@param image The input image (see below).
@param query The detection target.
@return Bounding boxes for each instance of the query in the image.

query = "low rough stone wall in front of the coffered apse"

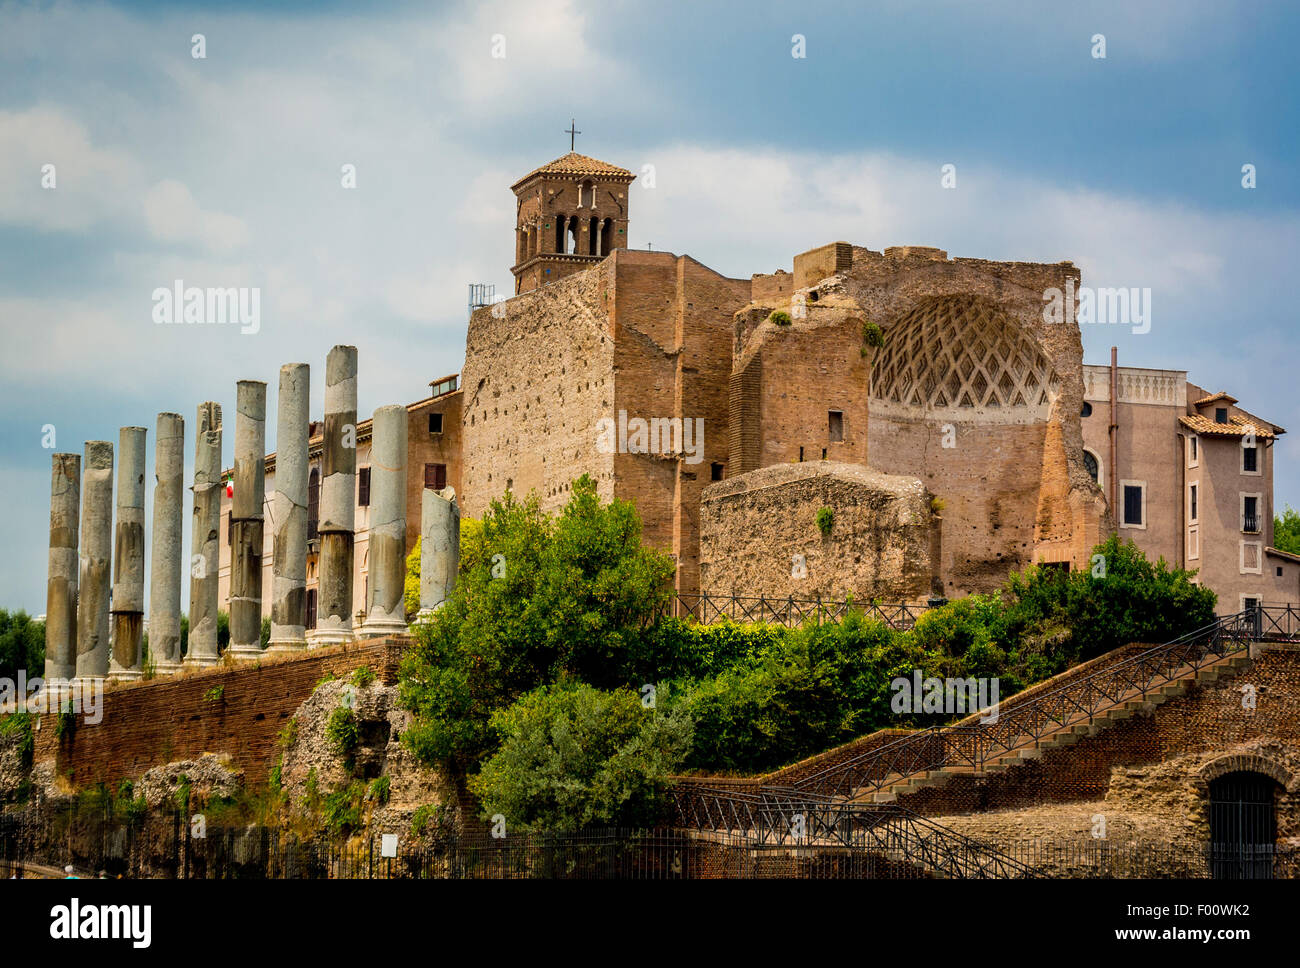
[701,461,939,603]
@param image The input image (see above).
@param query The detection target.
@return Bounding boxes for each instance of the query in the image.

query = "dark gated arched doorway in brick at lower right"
[1209,771,1278,880]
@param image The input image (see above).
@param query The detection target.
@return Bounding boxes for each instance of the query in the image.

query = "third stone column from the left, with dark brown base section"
[108,427,148,680]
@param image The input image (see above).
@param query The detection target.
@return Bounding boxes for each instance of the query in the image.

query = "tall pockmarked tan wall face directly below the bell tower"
[460,260,614,517]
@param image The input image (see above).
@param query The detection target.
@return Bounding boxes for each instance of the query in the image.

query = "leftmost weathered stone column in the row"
[46,453,81,695]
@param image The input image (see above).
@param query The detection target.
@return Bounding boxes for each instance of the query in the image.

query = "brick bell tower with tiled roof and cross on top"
[511,125,636,295]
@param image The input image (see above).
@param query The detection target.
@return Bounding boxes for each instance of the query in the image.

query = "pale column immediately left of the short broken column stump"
[361,407,407,637]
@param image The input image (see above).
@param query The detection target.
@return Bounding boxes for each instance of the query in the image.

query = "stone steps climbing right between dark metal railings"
[844,652,1251,803]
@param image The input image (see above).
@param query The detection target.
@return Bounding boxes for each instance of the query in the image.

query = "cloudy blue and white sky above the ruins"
[0,0,1300,615]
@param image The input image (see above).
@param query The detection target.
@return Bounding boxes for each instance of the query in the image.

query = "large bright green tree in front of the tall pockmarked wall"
[402,476,673,769]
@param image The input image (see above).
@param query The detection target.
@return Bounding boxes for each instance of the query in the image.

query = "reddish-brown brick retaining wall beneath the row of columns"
[35,639,407,789]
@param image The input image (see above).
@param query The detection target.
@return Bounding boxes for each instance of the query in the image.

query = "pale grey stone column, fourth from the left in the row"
[150,413,185,676]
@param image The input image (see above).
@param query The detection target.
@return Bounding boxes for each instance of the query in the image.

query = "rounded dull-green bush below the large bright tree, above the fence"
[469,680,692,830]
